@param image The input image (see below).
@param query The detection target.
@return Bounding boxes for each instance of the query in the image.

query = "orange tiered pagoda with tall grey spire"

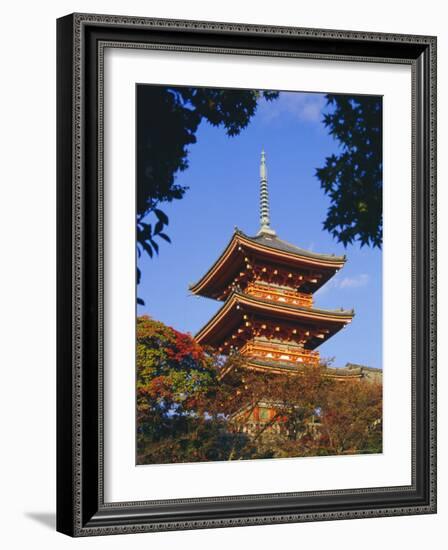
[190,151,380,436]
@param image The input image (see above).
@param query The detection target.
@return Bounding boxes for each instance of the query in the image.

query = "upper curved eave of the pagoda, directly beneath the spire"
[190,231,346,297]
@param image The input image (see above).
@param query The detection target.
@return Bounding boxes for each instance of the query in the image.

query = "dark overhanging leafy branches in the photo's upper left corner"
[137,85,278,264]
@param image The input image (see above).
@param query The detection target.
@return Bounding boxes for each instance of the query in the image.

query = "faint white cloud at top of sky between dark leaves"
[258,92,326,123]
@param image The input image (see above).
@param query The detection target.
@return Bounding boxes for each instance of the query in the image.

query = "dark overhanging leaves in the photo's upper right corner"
[316,94,383,247]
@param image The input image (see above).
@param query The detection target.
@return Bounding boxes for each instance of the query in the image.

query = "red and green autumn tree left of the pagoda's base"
[137,316,253,464]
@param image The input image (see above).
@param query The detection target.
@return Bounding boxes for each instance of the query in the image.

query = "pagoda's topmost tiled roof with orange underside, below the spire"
[190,228,346,298]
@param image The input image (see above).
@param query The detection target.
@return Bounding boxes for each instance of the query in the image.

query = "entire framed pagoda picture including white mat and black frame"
[57,14,436,536]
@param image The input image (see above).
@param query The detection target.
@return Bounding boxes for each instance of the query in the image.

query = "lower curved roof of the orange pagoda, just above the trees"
[195,291,354,349]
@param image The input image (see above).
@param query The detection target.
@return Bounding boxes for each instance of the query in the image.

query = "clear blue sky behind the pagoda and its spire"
[137,92,382,368]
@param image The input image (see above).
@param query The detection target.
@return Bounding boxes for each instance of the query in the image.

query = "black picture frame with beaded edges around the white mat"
[57,14,436,536]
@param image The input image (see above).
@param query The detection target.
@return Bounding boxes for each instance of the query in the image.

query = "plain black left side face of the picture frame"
[56,12,74,535]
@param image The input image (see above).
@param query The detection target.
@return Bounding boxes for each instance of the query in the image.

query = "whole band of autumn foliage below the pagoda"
[137,316,382,464]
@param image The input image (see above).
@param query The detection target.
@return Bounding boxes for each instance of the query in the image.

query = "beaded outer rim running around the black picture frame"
[57,14,436,536]
